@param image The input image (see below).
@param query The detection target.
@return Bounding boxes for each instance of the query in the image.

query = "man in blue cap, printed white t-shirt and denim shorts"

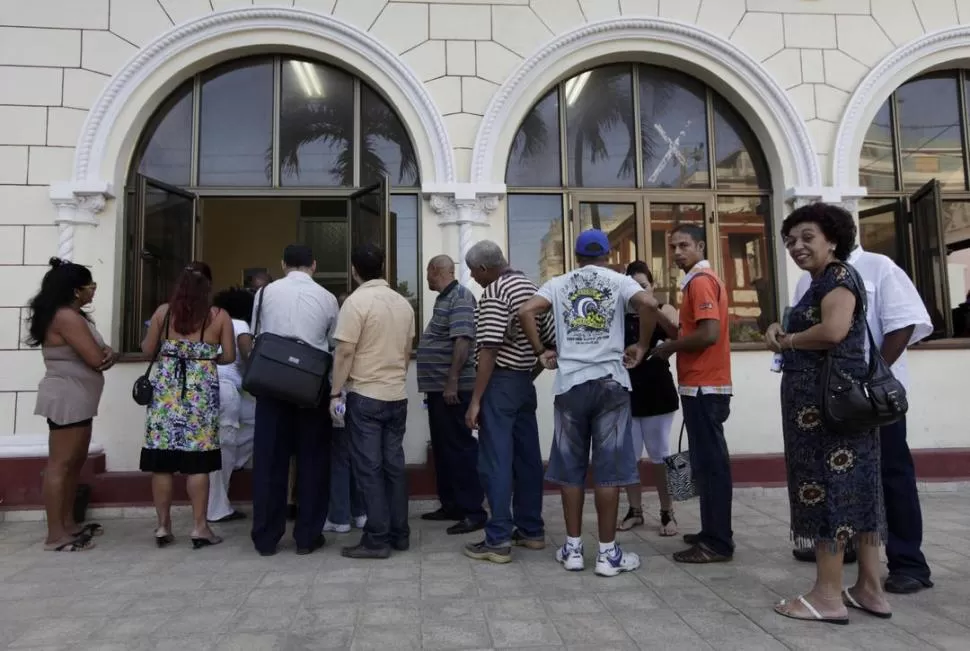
[519,229,658,576]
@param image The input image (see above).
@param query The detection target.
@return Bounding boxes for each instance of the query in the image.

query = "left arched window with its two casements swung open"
[124,56,420,350]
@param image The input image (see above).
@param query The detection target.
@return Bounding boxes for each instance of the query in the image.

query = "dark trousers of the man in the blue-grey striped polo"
[427,391,487,522]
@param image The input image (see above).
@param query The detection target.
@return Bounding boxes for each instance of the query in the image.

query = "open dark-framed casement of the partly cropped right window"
[909,179,953,337]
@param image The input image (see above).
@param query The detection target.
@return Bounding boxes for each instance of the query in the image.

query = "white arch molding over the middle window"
[471,18,822,194]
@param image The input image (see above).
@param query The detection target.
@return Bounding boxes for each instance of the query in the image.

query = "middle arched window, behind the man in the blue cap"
[505,64,777,342]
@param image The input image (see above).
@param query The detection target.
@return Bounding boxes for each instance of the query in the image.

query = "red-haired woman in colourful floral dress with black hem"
[139,262,236,549]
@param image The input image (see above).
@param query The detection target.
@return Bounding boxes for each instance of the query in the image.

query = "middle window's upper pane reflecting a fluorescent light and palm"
[564,65,636,188]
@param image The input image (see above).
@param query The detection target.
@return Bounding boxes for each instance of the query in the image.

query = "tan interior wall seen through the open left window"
[201,197,300,291]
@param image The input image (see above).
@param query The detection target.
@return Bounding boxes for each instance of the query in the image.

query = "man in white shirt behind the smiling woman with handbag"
[792,246,933,594]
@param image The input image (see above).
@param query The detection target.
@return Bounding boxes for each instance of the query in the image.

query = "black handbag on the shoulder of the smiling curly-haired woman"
[821,264,909,435]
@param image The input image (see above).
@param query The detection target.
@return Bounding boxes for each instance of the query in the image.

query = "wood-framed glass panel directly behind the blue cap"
[569,194,645,273]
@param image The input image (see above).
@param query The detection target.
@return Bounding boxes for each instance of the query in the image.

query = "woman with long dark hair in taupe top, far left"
[27,258,116,552]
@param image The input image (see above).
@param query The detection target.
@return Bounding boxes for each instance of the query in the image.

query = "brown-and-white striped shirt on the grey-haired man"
[475,270,555,371]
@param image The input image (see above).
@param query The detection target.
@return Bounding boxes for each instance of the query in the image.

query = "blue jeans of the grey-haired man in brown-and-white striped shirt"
[478,368,545,547]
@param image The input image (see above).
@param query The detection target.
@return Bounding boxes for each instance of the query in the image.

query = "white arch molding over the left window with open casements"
[45,7,455,257]
